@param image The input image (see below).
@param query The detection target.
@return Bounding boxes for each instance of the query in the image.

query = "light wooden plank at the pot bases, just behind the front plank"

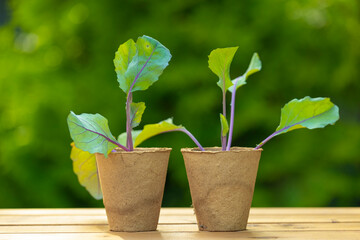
[0,223,360,234]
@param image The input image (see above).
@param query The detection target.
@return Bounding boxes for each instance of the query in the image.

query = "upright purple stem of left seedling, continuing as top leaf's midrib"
[126,44,157,151]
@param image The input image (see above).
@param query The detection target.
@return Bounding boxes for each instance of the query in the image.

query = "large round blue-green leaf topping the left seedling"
[114,35,171,93]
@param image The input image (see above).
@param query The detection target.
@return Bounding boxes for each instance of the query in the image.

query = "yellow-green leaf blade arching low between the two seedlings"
[135,118,184,146]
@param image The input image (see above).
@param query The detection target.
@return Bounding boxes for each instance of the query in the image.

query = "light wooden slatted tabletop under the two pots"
[0,208,360,240]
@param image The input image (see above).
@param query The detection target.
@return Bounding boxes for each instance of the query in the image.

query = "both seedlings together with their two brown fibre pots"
[67,36,339,231]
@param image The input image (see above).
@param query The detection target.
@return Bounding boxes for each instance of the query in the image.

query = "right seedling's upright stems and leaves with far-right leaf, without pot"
[198,47,339,151]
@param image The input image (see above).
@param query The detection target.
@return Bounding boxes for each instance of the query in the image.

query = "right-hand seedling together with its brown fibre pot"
[181,47,339,232]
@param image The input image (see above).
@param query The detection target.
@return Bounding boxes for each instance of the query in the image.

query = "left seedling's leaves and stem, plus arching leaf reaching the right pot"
[67,36,203,199]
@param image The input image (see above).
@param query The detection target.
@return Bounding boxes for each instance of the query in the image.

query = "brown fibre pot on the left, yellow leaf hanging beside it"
[96,148,171,232]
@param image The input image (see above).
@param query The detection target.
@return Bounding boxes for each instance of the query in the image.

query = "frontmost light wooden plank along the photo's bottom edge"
[0,231,360,240]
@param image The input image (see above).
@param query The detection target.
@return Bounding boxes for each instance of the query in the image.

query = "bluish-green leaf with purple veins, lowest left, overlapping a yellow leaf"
[67,112,117,157]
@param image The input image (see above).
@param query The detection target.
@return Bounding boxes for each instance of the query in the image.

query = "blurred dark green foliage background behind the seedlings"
[0,0,360,208]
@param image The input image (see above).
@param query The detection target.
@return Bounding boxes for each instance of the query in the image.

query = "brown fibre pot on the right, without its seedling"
[181,147,262,231]
